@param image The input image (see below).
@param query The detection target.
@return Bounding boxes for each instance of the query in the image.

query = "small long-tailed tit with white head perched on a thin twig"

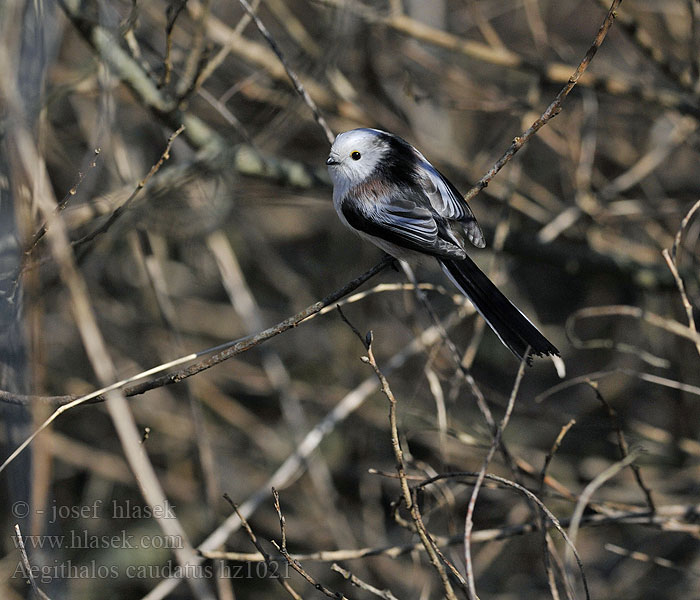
[326,129,559,360]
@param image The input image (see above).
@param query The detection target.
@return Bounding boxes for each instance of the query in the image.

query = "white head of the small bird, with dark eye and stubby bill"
[326,129,389,192]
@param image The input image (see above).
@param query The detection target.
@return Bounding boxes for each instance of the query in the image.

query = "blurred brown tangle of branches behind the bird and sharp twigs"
[0,0,700,600]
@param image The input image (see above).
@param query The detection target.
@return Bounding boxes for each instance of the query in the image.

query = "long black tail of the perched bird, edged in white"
[438,257,559,362]
